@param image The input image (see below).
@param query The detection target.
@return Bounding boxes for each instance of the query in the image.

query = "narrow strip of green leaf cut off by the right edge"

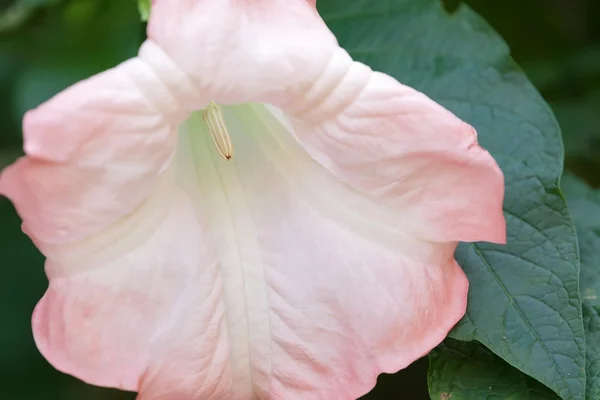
[562,175,600,400]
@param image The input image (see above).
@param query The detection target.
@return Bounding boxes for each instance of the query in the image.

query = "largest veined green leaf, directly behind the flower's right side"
[319,0,586,400]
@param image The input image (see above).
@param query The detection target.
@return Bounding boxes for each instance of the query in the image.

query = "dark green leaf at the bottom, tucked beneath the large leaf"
[428,339,560,400]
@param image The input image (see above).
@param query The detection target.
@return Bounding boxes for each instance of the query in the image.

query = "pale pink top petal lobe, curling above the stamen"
[148,0,344,108]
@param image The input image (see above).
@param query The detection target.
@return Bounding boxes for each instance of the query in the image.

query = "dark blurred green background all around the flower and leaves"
[0,0,600,400]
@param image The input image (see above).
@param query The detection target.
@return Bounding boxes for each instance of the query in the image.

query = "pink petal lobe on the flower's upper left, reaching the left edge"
[0,49,197,247]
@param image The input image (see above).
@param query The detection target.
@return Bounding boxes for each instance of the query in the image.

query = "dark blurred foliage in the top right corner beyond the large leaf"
[467,0,600,186]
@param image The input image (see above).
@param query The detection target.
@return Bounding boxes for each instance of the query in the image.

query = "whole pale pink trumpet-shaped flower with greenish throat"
[0,0,505,400]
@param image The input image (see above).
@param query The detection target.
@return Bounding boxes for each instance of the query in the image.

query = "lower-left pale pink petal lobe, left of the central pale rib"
[33,180,231,400]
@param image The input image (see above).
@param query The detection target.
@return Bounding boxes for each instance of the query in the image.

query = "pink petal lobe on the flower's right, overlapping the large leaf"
[291,72,506,243]
